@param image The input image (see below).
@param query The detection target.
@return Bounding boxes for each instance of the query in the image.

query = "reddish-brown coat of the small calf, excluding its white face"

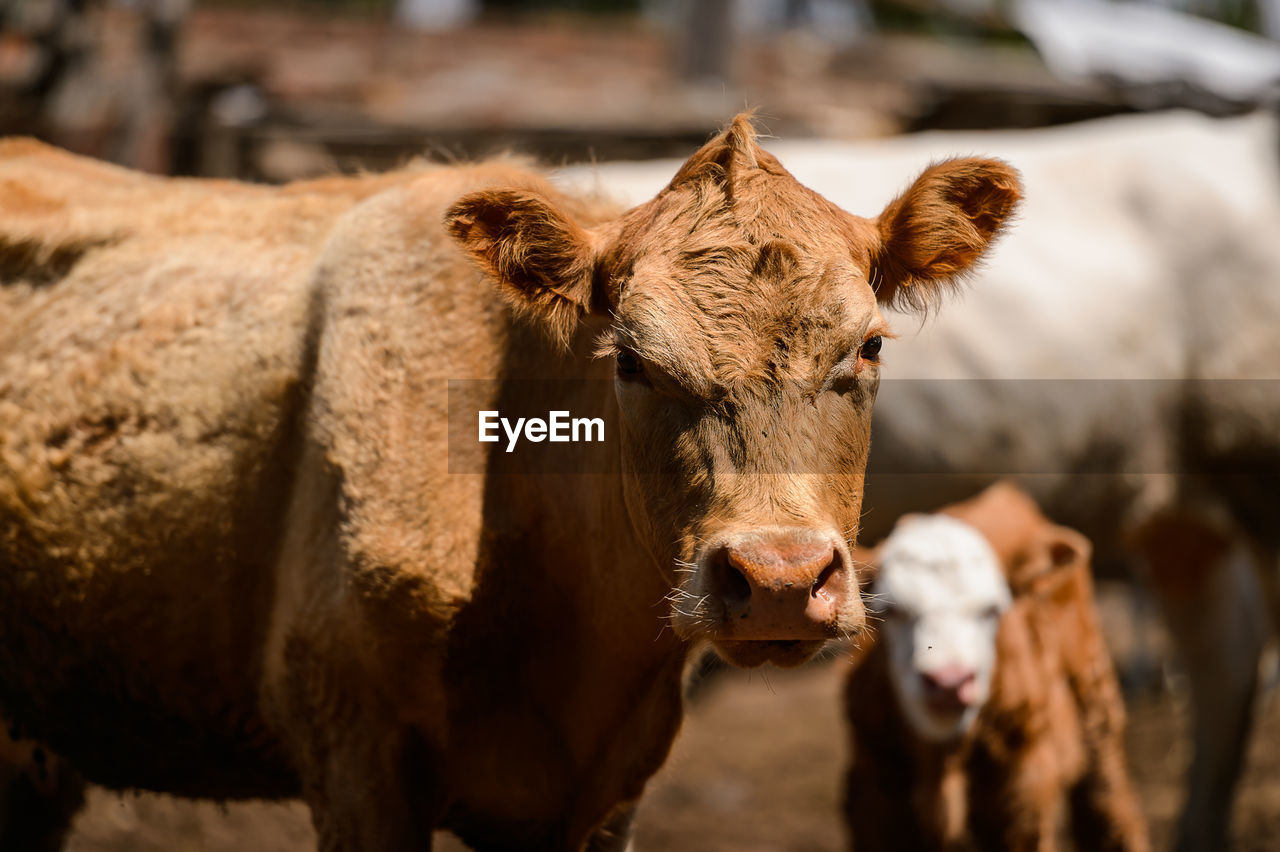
[846,484,1149,851]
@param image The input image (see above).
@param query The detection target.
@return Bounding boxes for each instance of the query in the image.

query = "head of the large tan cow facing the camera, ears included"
[447,116,1020,665]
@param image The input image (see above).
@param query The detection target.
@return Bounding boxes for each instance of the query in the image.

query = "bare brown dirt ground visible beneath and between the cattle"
[69,647,1280,852]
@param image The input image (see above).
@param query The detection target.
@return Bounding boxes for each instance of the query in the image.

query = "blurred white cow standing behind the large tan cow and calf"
[564,114,1280,849]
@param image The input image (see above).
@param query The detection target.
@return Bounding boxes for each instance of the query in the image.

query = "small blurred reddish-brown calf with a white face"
[846,484,1149,851]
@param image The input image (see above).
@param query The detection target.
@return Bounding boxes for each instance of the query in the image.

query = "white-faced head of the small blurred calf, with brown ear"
[861,482,1091,742]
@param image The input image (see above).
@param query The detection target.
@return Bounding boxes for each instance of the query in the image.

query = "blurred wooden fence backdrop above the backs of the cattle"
[0,0,1280,182]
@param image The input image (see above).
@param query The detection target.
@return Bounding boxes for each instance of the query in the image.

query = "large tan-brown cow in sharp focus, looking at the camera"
[0,118,1019,849]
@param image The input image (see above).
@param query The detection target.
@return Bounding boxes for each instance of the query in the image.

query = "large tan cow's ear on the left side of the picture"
[444,189,596,347]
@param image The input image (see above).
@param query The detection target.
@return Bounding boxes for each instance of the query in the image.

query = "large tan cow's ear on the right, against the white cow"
[873,157,1023,310]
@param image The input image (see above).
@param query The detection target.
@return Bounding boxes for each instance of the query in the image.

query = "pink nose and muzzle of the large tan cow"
[712,530,864,641]
